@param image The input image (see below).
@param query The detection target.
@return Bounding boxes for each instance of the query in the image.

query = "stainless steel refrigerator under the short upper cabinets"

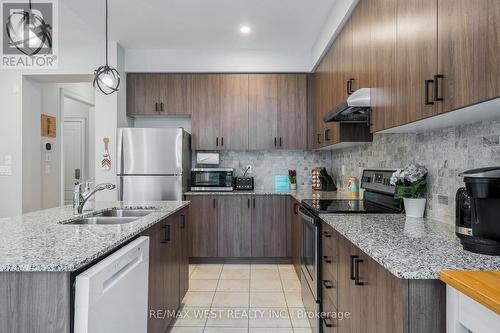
[117,128,191,201]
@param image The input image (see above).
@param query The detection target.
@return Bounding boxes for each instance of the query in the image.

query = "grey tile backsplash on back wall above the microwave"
[193,150,333,190]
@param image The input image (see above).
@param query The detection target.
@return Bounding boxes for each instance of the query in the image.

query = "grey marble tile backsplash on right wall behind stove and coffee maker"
[332,120,500,224]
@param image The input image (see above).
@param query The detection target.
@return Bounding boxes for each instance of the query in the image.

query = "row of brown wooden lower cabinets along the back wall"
[188,194,290,258]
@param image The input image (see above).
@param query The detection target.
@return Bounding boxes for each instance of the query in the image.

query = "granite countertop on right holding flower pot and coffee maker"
[320,214,500,279]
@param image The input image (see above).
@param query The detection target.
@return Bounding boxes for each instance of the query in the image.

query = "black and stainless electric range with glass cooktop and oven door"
[298,170,403,333]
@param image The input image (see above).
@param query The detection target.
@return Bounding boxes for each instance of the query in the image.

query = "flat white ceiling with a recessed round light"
[64,0,339,50]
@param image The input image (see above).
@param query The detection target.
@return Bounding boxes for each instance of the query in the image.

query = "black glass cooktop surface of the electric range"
[302,199,396,214]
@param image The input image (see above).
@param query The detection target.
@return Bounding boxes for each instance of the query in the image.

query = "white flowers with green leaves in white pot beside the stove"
[391,163,427,217]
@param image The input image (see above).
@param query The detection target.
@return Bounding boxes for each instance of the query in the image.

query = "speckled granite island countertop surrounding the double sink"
[0,201,189,272]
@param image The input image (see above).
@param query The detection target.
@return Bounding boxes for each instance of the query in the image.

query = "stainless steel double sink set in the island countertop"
[61,207,158,225]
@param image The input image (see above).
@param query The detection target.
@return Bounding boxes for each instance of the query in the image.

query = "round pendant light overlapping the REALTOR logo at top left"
[5,0,52,56]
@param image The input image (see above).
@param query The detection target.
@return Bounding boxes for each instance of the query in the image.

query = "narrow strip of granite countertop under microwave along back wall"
[185,188,356,201]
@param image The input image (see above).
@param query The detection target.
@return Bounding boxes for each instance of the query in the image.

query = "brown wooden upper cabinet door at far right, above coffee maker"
[436,0,500,112]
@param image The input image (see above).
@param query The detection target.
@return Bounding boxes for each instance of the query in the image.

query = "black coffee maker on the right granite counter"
[455,167,500,256]
